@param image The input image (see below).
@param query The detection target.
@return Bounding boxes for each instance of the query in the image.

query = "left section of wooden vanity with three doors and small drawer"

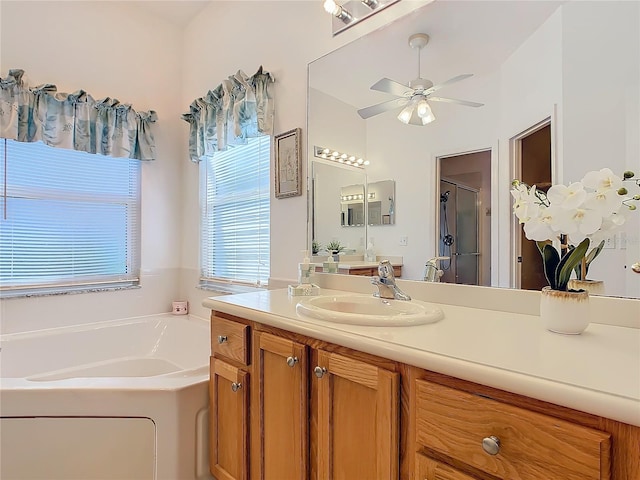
[210,313,400,480]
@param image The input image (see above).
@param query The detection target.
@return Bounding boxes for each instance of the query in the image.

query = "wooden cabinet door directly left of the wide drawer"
[314,350,399,480]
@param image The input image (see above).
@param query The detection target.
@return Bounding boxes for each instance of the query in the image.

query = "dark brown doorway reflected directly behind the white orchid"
[513,119,552,290]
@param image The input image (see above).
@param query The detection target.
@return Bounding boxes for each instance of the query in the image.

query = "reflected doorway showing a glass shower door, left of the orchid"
[438,150,491,286]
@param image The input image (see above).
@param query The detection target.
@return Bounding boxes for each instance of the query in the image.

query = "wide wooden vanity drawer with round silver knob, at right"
[415,380,611,480]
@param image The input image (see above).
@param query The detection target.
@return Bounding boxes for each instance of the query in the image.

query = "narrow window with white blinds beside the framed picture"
[200,135,271,290]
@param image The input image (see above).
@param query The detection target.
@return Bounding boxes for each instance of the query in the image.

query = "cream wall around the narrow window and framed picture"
[181,0,431,315]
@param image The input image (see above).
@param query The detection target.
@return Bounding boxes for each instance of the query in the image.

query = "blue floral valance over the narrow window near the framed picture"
[182,67,275,162]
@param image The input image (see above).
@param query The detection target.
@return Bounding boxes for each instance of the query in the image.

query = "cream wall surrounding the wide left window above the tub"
[0,0,184,332]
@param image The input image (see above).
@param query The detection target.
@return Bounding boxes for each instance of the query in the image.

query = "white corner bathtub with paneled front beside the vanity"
[0,314,212,480]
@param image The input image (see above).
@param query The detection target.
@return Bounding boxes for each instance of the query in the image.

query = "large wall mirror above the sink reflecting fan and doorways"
[308,0,640,298]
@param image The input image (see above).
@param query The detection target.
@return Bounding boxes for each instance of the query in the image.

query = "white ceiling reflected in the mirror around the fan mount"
[310,0,565,108]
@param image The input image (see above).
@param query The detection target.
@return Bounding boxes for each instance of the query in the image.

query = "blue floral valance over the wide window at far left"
[0,69,157,160]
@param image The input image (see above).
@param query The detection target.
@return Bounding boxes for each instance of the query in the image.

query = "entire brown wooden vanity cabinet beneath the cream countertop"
[210,312,640,480]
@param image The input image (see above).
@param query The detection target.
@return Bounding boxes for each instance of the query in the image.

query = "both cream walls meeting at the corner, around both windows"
[0,0,431,332]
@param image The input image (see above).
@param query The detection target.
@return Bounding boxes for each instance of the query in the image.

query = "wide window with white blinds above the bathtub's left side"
[0,139,140,296]
